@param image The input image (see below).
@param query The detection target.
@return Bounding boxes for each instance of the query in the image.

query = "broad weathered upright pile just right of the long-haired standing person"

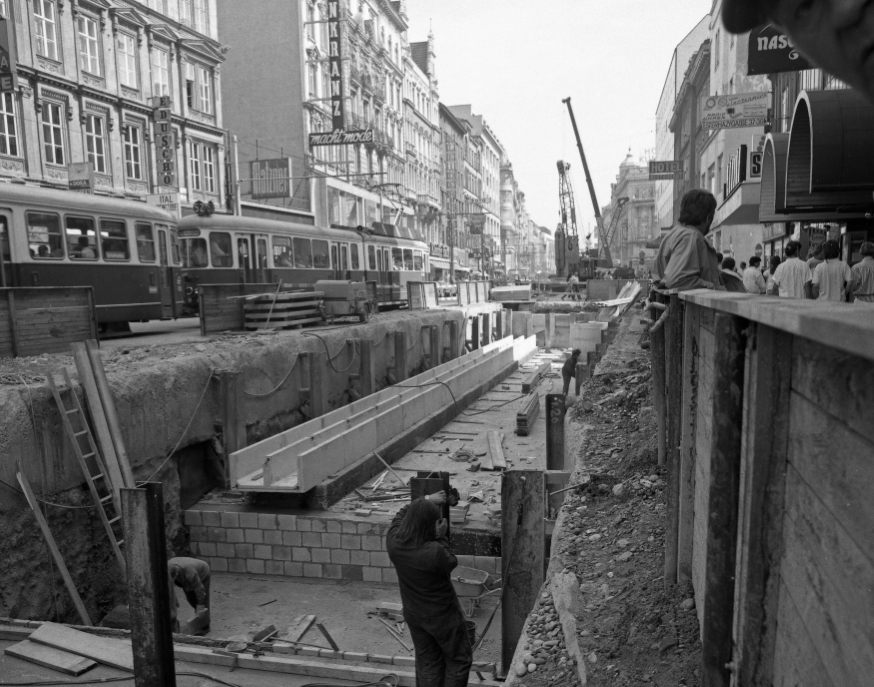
[501,470,546,666]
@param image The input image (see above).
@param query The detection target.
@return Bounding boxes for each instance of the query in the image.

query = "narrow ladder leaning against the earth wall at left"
[46,368,127,577]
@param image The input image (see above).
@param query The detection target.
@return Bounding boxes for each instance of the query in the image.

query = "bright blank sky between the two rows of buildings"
[407,0,711,231]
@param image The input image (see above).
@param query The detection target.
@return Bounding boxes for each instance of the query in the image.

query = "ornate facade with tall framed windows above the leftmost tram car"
[0,0,226,211]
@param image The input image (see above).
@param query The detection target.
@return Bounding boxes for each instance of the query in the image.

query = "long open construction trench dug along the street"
[0,284,700,685]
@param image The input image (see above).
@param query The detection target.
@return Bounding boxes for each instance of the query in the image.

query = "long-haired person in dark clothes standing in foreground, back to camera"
[385,492,473,687]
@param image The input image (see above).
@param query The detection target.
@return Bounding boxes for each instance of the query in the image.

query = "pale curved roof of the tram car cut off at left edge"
[0,183,175,224]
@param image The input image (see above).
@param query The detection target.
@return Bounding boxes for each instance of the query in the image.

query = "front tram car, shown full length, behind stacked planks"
[179,215,429,311]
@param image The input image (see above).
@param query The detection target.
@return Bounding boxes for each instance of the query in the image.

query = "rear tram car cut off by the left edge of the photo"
[0,182,184,331]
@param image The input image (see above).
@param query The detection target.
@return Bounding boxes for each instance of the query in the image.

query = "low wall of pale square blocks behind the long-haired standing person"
[184,510,501,584]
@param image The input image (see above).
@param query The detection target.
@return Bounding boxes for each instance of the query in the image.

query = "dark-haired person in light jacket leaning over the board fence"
[653,189,725,291]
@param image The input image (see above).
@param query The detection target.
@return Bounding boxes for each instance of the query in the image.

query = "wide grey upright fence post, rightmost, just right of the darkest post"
[728,326,794,685]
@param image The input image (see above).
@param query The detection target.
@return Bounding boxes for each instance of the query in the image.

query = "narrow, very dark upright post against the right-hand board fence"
[701,313,744,687]
